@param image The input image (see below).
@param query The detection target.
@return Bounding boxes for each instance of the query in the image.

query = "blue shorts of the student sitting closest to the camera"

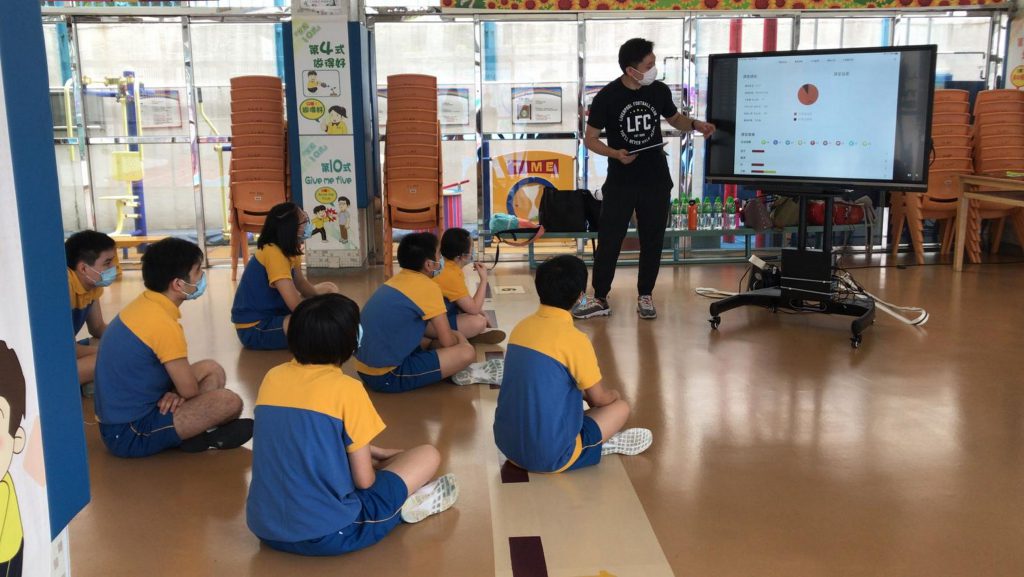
[263,470,409,555]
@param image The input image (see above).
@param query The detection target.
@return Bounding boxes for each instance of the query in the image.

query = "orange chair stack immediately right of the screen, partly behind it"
[892,90,974,264]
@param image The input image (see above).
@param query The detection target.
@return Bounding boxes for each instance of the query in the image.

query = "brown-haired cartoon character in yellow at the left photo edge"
[0,340,26,577]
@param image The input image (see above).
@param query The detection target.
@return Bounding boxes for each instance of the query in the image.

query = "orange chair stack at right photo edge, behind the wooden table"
[967,89,1024,262]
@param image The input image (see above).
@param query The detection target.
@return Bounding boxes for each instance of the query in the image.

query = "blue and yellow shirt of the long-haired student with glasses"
[231,244,302,329]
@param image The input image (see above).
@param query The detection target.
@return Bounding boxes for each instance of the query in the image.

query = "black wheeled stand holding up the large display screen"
[709,191,874,348]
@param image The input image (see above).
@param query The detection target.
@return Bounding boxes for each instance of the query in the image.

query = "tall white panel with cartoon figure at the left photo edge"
[0,78,52,577]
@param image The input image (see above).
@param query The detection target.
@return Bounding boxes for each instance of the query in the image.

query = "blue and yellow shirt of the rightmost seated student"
[495,305,601,472]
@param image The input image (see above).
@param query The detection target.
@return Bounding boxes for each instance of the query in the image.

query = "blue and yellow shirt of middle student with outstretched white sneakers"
[355,269,446,376]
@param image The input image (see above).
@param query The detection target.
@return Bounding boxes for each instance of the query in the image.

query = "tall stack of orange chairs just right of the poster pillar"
[383,74,443,277]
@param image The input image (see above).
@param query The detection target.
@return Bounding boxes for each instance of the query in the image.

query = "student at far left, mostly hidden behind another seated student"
[65,231,118,397]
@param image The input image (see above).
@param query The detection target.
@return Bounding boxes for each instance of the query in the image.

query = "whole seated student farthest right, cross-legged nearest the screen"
[495,255,651,472]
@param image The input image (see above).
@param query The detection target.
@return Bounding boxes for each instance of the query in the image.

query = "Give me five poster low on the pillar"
[299,135,362,269]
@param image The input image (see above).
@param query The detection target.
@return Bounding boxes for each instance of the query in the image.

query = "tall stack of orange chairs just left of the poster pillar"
[230,76,288,280]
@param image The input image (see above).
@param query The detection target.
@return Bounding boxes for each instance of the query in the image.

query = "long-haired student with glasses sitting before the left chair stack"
[231,202,338,351]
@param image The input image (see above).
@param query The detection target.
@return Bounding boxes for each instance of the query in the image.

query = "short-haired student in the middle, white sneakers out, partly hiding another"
[355,233,502,393]
